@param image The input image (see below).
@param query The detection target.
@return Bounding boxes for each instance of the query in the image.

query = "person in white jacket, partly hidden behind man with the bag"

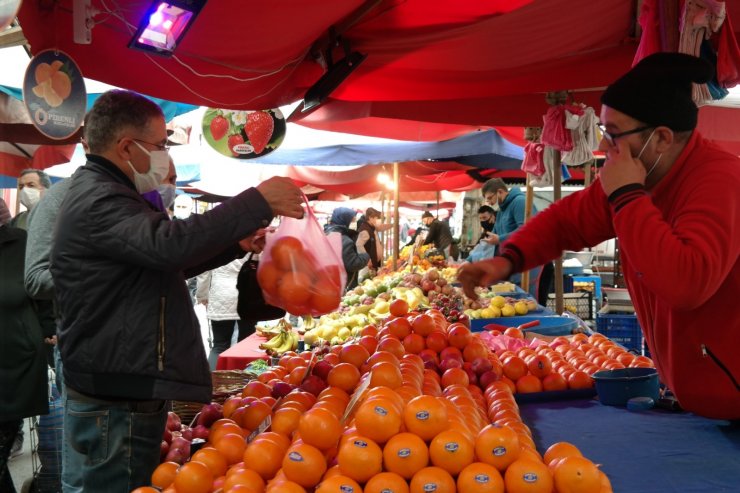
[195,257,257,370]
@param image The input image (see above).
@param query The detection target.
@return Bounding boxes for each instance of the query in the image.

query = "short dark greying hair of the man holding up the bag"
[84,89,163,154]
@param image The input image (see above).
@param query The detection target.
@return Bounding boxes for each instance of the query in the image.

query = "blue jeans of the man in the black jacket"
[63,389,167,493]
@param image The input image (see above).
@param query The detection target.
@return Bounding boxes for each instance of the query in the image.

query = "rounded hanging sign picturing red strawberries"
[203,108,285,159]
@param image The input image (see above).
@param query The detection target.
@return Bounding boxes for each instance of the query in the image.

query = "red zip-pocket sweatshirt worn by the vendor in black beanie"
[502,132,740,419]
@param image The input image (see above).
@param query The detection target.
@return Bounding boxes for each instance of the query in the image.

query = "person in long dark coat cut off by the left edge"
[0,199,49,493]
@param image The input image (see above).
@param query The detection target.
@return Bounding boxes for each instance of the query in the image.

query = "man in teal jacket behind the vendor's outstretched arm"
[481,178,555,305]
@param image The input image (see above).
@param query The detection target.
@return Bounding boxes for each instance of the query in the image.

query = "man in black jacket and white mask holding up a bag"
[51,90,303,492]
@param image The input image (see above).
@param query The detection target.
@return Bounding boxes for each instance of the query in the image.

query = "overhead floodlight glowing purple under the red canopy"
[128,0,206,56]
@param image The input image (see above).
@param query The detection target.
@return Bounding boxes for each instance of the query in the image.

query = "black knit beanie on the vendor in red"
[601,53,714,132]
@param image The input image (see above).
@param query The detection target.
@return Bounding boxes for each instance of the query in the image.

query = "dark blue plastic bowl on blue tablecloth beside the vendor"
[592,368,660,406]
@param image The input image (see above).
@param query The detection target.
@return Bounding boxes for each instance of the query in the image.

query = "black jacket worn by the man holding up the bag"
[51,156,272,402]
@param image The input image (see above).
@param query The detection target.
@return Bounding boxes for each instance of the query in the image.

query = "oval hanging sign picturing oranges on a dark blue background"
[23,50,87,140]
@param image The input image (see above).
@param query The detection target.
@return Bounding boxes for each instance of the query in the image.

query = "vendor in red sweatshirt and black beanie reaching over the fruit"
[458,53,740,420]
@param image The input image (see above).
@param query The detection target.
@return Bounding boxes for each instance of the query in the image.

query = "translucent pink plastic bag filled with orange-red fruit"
[257,199,347,316]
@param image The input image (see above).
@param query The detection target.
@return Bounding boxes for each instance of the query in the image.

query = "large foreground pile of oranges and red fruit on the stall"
[137,297,652,493]
